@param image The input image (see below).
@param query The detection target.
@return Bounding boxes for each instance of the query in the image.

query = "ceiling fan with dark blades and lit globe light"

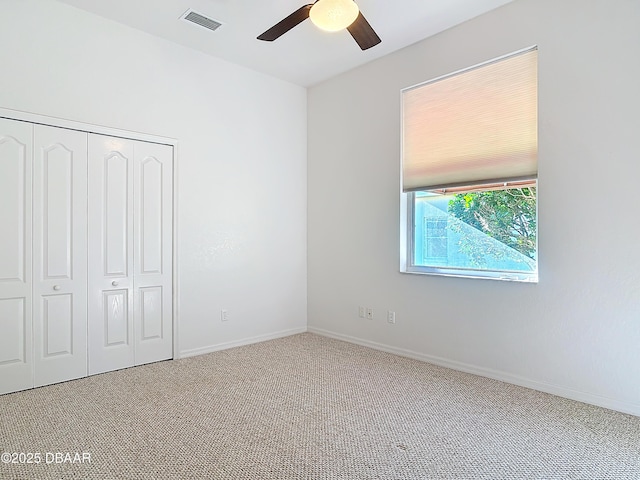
[258,0,382,50]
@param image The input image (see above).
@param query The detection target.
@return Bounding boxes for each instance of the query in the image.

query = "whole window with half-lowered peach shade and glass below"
[402,48,538,282]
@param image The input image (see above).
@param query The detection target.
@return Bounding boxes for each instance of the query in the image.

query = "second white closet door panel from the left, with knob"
[33,125,87,387]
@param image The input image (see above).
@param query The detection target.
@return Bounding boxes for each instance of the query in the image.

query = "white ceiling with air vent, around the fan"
[53,0,512,86]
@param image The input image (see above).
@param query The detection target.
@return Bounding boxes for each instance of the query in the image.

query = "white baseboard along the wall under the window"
[307,327,640,417]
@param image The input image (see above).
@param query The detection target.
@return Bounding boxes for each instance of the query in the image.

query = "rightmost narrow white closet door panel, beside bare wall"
[133,142,173,365]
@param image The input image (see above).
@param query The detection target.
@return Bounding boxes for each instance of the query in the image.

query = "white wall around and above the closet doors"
[0,0,306,353]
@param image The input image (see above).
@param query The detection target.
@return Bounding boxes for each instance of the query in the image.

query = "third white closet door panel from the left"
[88,134,134,375]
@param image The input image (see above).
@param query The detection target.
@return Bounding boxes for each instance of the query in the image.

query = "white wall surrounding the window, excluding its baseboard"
[308,0,640,415]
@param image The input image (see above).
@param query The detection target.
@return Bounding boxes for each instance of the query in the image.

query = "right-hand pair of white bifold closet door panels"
[88,134,173,374]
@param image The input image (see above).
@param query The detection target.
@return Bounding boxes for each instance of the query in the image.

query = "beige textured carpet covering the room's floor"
[0,334,640,480]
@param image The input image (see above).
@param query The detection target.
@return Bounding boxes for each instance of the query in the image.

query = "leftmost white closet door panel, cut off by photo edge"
[0,118,33,394]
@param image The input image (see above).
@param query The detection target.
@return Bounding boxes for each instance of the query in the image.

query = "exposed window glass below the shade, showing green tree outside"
[411,187,537,280]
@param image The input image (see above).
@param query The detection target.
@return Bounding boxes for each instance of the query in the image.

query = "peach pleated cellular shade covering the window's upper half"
[402,48,538,192]
